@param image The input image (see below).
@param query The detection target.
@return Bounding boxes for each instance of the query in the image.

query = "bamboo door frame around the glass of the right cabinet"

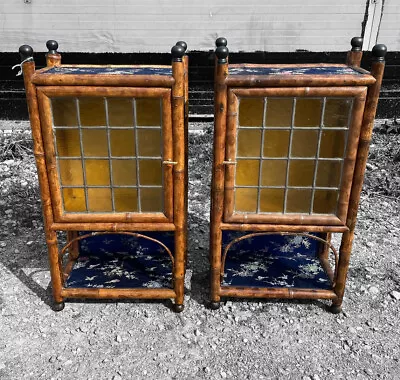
[224,87,367,225]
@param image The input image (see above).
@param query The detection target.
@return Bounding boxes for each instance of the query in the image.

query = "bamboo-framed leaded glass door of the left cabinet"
[39,87,173,221]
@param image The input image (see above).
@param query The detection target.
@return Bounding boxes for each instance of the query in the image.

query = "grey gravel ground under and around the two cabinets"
[0,122,400,380]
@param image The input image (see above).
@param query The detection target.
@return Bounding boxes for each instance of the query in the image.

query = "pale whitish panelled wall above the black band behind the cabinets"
[0,0,384,52]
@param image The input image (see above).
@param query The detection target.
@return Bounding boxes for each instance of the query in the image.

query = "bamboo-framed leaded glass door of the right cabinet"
[224,87,366,225]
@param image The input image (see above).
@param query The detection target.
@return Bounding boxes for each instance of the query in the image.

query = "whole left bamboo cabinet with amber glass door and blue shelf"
[19,41,187,312]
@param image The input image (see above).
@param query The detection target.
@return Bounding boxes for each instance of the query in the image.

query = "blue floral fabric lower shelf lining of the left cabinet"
[65,232,174,288]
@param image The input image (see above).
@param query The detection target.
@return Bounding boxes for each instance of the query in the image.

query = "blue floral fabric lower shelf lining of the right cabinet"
[221,231,332,289]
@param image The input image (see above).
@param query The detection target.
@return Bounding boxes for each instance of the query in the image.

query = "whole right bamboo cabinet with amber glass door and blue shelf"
[210,37,386,313]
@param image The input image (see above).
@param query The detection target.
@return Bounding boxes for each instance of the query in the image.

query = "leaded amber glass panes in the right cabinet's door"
[234,97,352,214]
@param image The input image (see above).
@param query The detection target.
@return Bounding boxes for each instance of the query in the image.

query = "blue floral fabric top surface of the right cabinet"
[229,66,361,75]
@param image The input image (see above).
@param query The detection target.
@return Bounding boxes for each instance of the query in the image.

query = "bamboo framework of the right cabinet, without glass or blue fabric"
[210,38,386,313]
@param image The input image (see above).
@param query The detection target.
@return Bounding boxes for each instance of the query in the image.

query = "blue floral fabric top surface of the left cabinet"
[43,66,172,75]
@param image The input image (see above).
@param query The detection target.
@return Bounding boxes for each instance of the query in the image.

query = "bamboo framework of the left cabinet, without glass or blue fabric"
[20,41,188,312]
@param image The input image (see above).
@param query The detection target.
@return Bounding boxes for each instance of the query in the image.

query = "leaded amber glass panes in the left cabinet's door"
[51,97,163,212]
